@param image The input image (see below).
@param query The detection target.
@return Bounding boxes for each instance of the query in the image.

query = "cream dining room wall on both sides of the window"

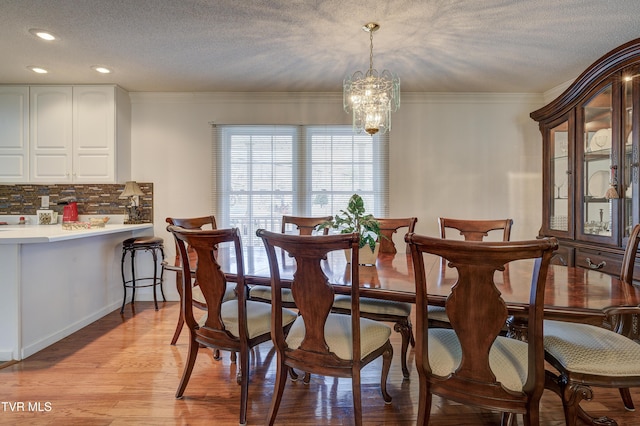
[131,93,543,300]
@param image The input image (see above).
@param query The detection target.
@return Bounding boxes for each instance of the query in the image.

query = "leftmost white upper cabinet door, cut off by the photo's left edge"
[0,86,29,183]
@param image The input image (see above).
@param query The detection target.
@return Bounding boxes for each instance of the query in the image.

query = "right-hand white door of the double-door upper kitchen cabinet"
[73,86,115,182]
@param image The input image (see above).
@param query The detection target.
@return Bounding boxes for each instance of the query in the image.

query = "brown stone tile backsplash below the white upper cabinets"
[0,182,153,223]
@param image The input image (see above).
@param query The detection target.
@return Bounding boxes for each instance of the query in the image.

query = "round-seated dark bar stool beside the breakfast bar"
[120,236,167,314]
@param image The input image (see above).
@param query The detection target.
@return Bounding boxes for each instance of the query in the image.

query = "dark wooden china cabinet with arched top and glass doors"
[531,39,640,275]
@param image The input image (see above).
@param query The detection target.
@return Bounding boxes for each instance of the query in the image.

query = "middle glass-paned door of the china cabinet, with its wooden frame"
[576,82,621,245]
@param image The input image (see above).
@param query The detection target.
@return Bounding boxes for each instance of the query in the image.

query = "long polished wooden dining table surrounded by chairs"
[181,245,640,425]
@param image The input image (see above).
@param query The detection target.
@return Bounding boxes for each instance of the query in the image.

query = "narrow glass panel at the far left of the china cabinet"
[549,121,573,232]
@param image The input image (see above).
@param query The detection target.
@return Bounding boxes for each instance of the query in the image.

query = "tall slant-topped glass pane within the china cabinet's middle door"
[578,84,619,240]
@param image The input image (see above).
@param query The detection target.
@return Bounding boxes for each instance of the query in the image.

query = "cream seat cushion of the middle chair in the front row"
[287,314,391,360]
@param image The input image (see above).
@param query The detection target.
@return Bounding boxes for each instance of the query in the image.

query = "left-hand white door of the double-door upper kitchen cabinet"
[29,86,73,183]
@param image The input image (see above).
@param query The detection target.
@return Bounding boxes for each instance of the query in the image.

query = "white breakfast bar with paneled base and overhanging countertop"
[0,223,153,362]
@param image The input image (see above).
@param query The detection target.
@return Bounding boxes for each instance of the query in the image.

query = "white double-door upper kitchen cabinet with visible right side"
[30,86,131,183]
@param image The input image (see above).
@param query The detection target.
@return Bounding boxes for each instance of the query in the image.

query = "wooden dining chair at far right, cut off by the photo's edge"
[544,225,640,425]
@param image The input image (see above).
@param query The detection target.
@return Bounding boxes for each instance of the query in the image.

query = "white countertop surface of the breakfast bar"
[0,223,153,244]
